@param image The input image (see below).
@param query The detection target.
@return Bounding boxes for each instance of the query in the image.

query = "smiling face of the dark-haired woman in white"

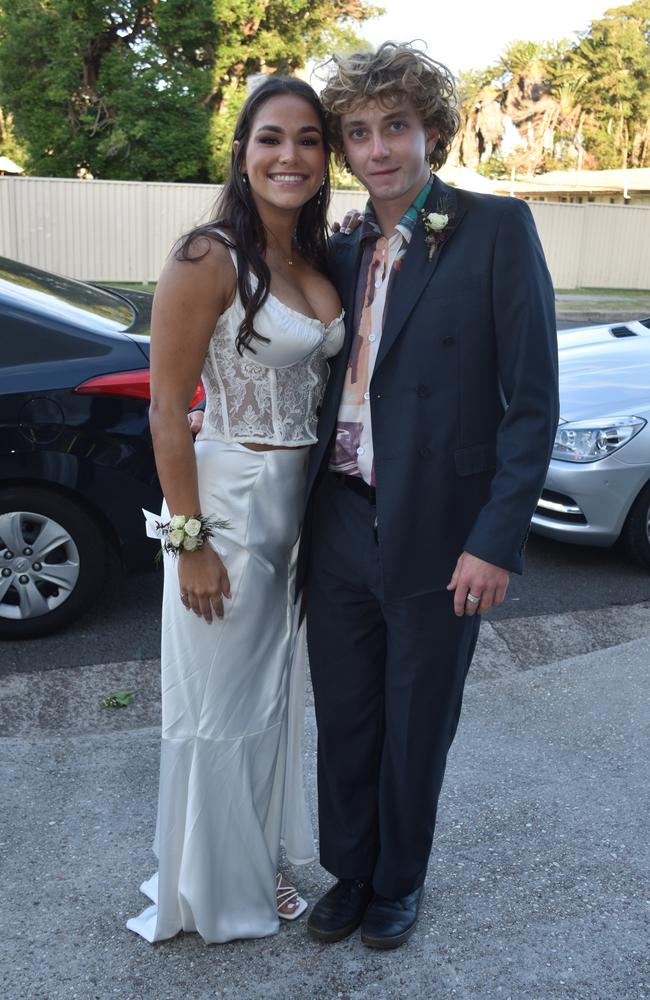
[241,94,327,215]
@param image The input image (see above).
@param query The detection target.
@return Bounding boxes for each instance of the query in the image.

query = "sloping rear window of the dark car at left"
[0,258,135,333]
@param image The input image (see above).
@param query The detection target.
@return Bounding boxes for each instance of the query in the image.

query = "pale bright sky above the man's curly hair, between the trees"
[360,0,612,73]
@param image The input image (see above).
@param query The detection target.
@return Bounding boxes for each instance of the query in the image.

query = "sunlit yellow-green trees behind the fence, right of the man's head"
[454,0,650,174]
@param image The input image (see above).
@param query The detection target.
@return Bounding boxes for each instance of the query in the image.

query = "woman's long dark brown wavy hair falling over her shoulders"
[175,76,331,354]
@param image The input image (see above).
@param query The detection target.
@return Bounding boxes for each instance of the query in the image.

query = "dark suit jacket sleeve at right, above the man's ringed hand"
[465,198,559,573]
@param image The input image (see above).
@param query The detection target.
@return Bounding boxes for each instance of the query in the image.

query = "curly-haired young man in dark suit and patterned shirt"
[299,43,558,948]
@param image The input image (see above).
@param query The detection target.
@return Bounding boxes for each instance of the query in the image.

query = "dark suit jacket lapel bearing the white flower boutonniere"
[375,177,466,371]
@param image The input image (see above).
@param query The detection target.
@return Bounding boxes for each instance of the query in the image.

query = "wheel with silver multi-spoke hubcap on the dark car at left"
[0,487,107,639]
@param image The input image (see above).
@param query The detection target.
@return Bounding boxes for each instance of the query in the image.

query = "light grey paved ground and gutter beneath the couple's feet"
[0,602,650,1000]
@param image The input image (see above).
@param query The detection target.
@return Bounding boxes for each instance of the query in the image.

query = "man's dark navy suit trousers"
[307,474,479,899]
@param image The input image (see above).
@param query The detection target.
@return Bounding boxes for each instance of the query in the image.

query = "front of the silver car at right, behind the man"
[532,319,650,568]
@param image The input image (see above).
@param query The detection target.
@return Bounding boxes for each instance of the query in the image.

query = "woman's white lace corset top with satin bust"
[199,238,344,447]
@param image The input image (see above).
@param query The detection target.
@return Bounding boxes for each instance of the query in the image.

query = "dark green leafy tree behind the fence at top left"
[0,0,215,180]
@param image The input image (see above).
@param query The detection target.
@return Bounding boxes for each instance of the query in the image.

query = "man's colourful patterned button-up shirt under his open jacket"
[330,179,433,486]
